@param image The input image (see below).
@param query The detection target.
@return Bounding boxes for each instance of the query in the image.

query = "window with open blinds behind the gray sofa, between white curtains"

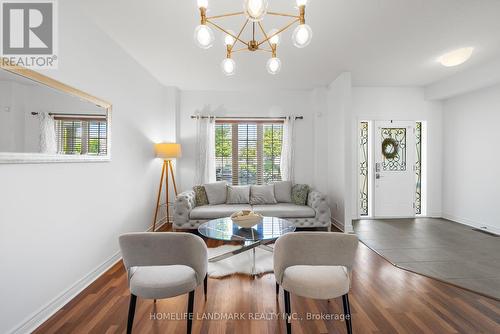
[215,121,283,185]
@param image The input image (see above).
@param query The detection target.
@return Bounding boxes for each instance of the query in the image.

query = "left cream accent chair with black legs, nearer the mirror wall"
[119,232,208,333]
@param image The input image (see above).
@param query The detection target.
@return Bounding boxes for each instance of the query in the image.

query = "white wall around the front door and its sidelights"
[352,87,443,217]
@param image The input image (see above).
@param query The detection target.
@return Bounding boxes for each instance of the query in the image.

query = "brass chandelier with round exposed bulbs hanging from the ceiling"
[194,0,312,76]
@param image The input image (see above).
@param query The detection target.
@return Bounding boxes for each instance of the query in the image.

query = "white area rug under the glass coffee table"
[208,245,273,278]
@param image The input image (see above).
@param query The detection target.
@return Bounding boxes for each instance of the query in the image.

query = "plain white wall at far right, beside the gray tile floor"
[443,85,500,233]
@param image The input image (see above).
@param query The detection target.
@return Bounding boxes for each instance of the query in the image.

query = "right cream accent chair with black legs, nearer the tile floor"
[274,232,358,334]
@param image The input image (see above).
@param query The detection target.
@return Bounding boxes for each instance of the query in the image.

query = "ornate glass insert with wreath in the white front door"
[381,128,406,171]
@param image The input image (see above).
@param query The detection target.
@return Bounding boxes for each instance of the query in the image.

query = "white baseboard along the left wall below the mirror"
[9,222,166,334]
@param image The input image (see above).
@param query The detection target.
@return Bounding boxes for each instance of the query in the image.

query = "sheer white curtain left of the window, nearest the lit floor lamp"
[195,116,215,184]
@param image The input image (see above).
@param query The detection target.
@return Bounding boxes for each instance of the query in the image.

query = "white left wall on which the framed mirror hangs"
[0,0,175,333]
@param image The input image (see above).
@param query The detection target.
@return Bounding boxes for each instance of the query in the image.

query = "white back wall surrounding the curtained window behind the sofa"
[177,91,314,191]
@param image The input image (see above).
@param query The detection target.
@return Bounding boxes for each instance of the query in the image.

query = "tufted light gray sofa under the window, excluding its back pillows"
[173,191,331,231]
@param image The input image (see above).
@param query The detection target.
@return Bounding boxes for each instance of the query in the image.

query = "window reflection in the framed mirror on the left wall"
[55,117,108,155]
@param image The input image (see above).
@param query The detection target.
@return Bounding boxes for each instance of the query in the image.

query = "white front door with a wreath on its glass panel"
[373,121,416,218]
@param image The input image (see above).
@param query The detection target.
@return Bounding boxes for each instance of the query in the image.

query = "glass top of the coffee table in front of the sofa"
[198,217,295,241]
